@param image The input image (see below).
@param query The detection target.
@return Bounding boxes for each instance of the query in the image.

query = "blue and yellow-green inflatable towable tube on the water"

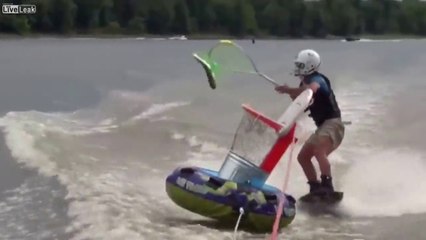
[166,167,296,232]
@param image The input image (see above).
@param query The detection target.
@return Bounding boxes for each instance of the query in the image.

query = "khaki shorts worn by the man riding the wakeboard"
[306,118,345,150]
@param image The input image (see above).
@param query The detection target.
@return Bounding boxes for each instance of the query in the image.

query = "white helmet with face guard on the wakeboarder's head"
[294,49,321,76]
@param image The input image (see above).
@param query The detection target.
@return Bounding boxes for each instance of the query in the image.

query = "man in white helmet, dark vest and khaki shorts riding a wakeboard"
[275,49,345,195]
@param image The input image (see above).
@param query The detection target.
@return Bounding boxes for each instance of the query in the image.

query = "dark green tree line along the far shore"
[0,0,426,37]
